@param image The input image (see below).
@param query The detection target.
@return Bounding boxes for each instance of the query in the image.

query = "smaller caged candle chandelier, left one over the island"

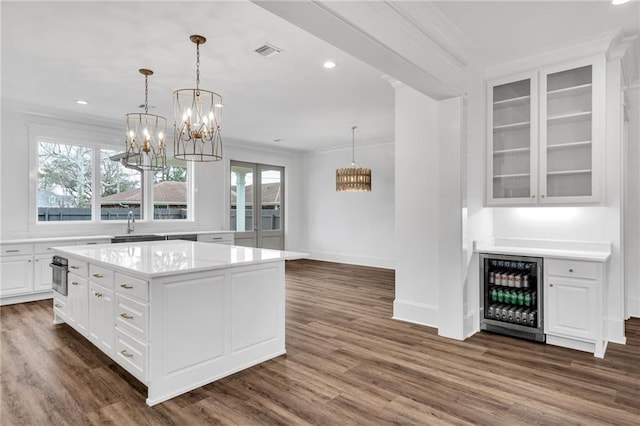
[122,68,167,170]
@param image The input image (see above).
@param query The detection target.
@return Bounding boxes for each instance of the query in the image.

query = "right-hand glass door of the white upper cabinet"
[540,64,596,202]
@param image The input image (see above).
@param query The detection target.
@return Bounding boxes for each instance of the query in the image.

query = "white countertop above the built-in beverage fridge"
[474,238,611,262]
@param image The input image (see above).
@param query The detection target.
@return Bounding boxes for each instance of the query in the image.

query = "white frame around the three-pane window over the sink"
[27,123,195,227]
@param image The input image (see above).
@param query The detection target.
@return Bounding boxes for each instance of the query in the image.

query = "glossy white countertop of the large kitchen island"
[52,240,305,279]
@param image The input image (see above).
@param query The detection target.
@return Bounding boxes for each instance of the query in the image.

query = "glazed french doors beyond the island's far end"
[229,161,284,250]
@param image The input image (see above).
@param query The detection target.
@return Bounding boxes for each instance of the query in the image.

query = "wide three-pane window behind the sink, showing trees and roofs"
[31,136,192,223]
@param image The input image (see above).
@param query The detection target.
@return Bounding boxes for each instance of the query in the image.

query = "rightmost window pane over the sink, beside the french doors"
[152,159,189,220]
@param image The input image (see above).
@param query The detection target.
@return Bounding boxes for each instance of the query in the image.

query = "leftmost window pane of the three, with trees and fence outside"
[36,141,93,222]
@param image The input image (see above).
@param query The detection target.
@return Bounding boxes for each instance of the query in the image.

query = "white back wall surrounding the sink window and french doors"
[0,101,303,250]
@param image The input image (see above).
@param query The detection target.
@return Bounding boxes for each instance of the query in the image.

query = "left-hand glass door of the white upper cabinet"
[487,76,536,204]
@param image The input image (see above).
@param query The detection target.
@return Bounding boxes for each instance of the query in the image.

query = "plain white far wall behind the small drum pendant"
[304,141,395,268]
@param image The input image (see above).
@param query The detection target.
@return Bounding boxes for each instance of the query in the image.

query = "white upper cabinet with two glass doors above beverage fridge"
[487,58,605,205]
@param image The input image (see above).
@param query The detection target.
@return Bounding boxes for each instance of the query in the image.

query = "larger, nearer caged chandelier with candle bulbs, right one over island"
[173,35,222,162]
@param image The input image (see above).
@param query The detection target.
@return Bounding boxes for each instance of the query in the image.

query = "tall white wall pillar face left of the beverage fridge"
[393,84,448,327]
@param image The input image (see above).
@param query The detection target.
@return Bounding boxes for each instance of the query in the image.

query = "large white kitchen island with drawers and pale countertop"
[48,240,302,406]
